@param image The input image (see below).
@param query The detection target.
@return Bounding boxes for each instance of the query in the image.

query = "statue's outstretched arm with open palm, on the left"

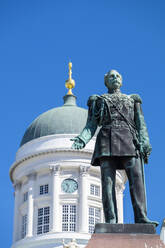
[71,95,98,149]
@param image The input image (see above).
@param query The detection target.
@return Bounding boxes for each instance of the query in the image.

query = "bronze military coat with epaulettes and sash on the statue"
[78,91,151,165]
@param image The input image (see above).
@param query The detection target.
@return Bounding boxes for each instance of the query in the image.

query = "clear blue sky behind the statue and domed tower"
[0,0,165,248]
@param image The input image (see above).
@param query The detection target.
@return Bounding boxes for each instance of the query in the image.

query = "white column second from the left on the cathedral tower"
[26,173,36,237]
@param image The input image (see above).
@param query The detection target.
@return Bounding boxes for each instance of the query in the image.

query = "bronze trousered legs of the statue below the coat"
[100,157,147,223]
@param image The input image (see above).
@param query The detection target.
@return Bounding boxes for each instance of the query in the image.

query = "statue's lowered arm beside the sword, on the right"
[133,95,152,163]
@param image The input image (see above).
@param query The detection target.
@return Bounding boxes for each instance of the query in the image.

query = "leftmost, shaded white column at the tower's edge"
[13,183,21,243]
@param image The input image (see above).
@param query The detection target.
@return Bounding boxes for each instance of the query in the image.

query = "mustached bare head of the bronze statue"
[104,70,122,91]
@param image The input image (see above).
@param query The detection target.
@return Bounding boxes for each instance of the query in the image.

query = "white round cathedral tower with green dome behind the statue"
[10,64,126,248]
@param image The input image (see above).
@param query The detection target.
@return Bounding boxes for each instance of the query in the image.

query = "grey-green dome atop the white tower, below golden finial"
[20,95,88,146]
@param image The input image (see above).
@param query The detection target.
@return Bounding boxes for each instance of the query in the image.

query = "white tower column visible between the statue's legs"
[116,184,125,223]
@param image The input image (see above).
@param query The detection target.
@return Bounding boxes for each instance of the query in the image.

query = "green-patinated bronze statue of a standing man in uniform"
[72,70,158,225]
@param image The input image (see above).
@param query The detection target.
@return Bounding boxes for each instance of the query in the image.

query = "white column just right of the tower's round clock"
[79,165,89,233]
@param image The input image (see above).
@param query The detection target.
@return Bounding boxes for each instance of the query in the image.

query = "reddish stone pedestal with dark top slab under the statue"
[86,223,165,248]
